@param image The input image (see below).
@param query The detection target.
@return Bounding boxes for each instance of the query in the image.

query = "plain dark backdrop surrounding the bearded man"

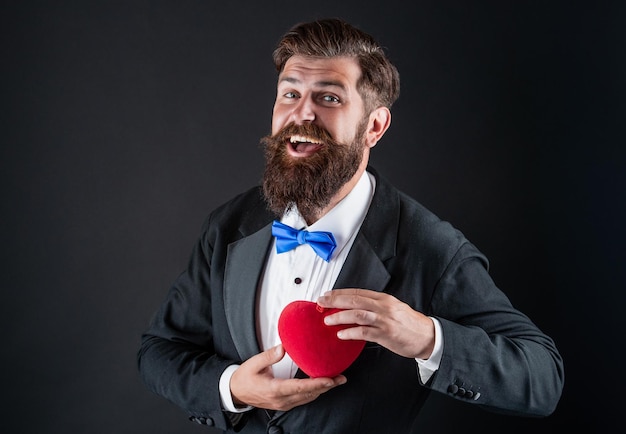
[0,0,626,434]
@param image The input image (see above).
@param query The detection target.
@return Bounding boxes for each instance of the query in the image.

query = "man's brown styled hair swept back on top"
[273,18,400,112]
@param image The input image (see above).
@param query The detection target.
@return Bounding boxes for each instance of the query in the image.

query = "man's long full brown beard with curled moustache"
[261,117,368,223]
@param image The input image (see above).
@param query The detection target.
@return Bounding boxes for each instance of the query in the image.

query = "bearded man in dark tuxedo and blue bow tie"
[138,19,564,434]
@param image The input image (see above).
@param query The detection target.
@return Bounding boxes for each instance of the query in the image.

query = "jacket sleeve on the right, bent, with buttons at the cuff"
[430,242,564,417]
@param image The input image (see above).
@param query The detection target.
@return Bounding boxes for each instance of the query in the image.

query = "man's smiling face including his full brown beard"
[263,56,369,222]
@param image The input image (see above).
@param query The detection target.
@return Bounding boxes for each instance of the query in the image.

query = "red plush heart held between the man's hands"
[278,300,365,377]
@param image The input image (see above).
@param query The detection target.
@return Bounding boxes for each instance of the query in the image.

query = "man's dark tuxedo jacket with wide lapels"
[138,168,564,434]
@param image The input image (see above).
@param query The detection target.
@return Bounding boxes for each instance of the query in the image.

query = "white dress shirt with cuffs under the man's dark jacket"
[220,172,443,412]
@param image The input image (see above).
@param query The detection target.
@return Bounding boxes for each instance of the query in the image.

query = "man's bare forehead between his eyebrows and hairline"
[278,56,361,89]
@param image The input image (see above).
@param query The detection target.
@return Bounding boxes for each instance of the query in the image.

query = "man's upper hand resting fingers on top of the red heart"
[317,288,435,359]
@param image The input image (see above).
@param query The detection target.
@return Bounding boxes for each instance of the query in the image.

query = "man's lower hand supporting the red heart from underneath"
[230,345,346,411]
